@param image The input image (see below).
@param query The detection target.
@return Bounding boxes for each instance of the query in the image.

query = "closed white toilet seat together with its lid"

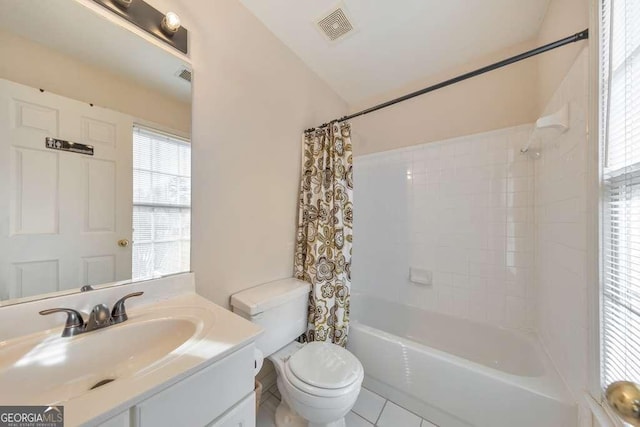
[283,342,364,397]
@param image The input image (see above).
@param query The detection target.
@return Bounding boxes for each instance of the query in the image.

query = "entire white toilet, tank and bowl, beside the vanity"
[231,279,364,427]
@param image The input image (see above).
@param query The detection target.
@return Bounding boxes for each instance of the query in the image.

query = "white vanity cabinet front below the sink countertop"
[99,344,255,427]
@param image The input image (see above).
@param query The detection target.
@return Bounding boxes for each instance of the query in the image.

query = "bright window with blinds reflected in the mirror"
[132,127,191,280]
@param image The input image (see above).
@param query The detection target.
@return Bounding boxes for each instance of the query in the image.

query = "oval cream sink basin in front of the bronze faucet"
[0,307,214,405]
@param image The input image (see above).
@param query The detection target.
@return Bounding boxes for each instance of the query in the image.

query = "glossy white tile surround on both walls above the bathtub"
[353,46,595,425]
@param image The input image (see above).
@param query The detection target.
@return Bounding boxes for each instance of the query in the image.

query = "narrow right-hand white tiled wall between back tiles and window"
[535,49,595,424]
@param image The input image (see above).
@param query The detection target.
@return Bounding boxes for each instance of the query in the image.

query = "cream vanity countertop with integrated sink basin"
[0,276,262,426]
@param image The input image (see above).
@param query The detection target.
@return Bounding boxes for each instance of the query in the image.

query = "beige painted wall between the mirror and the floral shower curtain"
[185,0,346,306]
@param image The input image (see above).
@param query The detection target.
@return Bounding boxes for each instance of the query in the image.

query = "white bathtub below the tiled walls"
[347,294,577,427]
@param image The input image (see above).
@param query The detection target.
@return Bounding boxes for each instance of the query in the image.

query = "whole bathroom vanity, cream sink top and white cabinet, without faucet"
[0,274,262,427]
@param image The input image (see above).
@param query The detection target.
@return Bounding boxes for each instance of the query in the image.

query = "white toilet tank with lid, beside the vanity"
[231,278,311,357]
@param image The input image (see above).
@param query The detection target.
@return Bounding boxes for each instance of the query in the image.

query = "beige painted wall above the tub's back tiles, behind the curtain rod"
[350,41,538,155]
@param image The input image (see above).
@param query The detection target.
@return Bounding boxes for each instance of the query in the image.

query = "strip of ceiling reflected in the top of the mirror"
[0,0,191,103]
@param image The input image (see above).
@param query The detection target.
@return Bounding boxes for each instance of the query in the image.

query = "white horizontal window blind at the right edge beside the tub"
[600,0,640,387]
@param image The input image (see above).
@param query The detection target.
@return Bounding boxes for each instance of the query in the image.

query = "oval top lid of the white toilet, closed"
[287,341,362,389]
